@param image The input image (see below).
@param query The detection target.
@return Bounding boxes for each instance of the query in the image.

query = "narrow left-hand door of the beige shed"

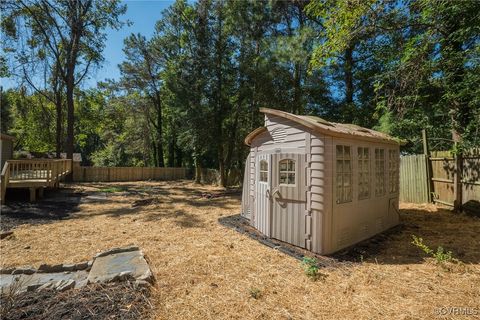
[254,154,272,236]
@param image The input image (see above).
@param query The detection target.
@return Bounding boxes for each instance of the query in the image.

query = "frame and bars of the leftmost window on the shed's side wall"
[335,144,353,204]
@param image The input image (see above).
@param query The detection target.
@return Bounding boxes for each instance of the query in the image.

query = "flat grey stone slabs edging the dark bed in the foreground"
[0,246,154,293]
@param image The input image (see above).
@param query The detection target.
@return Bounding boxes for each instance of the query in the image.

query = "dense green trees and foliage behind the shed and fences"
[0,0,480,178]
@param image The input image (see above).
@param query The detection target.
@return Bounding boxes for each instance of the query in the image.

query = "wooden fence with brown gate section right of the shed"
[400,149,480,206]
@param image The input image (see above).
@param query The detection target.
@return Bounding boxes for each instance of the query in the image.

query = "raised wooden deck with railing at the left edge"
[0,159,72,203]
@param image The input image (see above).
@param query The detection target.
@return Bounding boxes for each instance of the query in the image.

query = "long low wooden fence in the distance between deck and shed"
[73,166,186,182]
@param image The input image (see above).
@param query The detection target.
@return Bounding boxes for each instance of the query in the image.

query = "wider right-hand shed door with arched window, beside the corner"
[271,153,307,248]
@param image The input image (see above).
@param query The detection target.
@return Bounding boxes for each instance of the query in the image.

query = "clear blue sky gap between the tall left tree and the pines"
[1,0,174,89]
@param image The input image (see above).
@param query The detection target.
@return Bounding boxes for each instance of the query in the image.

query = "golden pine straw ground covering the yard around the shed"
[1,182,480,319]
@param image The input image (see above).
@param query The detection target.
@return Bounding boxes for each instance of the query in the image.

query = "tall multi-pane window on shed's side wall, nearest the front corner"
[336,145,352,203]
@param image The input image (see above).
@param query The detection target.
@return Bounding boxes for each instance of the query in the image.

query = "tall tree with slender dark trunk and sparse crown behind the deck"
[4,0,126,170]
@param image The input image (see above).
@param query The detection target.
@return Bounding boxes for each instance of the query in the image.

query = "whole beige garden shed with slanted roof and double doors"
[242,108,399,254]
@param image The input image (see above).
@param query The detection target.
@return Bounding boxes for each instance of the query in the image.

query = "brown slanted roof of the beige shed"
[245,108,400,145]
